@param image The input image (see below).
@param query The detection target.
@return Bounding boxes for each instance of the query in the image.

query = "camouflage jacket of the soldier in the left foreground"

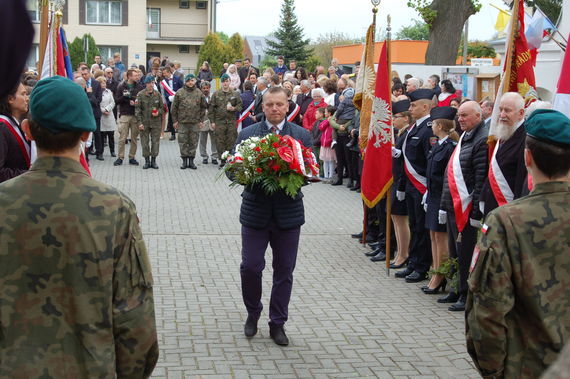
[0,157,158,378]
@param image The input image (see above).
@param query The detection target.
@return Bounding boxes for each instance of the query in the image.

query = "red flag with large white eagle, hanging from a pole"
[361,42,393,208]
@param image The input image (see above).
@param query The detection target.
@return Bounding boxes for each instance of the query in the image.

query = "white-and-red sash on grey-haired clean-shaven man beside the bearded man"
[447,133,473,233]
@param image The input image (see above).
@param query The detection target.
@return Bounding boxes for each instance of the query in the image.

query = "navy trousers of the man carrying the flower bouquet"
[240,222,301,325]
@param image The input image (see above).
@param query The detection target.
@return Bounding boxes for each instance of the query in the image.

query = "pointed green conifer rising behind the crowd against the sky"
[266,0,312,65]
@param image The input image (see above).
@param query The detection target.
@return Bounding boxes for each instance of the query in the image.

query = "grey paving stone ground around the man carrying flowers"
[91,139,478,379]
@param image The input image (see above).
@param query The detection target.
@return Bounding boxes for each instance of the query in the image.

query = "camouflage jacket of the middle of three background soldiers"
[170,85,208,124]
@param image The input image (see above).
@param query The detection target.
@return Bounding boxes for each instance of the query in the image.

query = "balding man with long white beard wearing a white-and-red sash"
[479,92,528,216]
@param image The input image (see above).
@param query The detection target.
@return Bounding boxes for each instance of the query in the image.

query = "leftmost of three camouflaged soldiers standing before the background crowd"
[135,75,164,169]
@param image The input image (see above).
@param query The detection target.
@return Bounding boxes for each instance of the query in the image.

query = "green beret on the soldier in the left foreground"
[30,76,97,134]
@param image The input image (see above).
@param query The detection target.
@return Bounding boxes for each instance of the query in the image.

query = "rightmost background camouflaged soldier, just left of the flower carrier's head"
[208,74,242,166]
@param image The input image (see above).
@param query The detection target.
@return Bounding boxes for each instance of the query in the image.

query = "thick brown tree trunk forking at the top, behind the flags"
[407,0,481,65]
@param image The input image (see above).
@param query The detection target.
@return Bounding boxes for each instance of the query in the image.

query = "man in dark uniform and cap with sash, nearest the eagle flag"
[395,88,437,283]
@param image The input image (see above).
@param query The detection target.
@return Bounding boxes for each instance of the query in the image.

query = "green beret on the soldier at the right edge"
[525,109,570,146]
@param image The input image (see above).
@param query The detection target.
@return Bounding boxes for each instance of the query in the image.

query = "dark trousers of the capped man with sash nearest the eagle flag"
[406,186,432,274]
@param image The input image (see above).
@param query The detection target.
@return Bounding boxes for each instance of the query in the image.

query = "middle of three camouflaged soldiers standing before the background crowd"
[171,74,208,170]
